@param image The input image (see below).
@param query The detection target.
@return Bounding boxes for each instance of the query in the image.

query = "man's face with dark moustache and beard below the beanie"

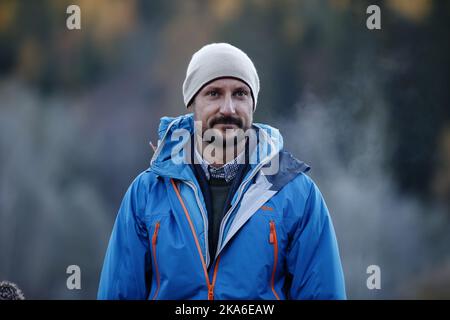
[189,78,253,141]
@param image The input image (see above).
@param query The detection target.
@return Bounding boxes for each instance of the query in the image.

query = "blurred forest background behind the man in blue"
[0,0,450,299]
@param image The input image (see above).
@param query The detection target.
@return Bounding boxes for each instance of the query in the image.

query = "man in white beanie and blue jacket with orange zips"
[98,43,345,300]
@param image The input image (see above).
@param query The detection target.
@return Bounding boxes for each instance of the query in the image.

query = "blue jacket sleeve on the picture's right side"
[287,180,346,300]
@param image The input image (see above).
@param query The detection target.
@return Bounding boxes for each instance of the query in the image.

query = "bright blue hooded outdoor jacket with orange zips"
[98,114,346,300]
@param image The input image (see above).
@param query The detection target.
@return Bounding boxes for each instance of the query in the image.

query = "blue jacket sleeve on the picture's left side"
[97,177,151,300]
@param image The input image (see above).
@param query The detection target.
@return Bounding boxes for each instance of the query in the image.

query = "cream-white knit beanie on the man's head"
[183,43,259,110]
